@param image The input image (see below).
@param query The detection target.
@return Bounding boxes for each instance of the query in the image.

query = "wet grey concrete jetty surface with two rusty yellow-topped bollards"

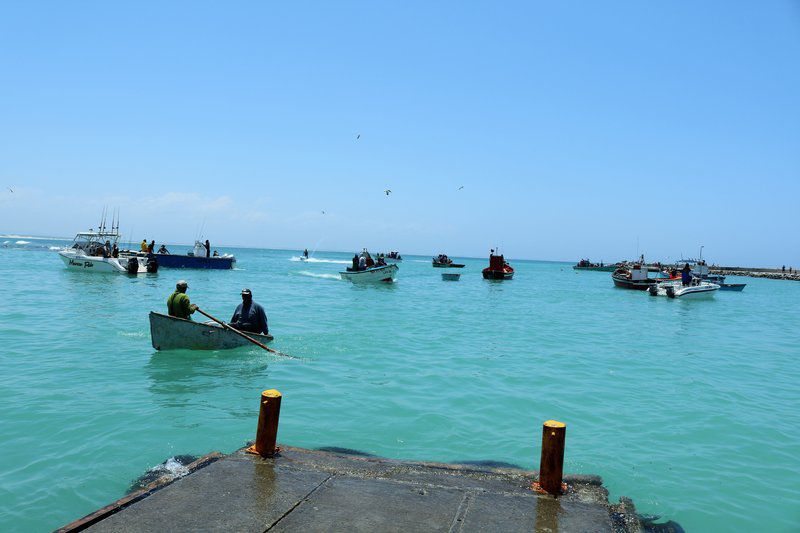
[59,447,652,532]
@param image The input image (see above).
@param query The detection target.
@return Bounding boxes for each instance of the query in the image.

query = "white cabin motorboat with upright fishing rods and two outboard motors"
[58,215,158,274]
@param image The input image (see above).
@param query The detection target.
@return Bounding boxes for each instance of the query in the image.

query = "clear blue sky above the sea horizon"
[0,0,800,267]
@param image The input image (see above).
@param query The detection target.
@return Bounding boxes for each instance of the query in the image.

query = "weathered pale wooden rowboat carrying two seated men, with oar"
[150,311,273,350]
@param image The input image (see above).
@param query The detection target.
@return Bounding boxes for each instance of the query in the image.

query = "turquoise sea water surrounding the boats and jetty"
[0,239,800,531]
